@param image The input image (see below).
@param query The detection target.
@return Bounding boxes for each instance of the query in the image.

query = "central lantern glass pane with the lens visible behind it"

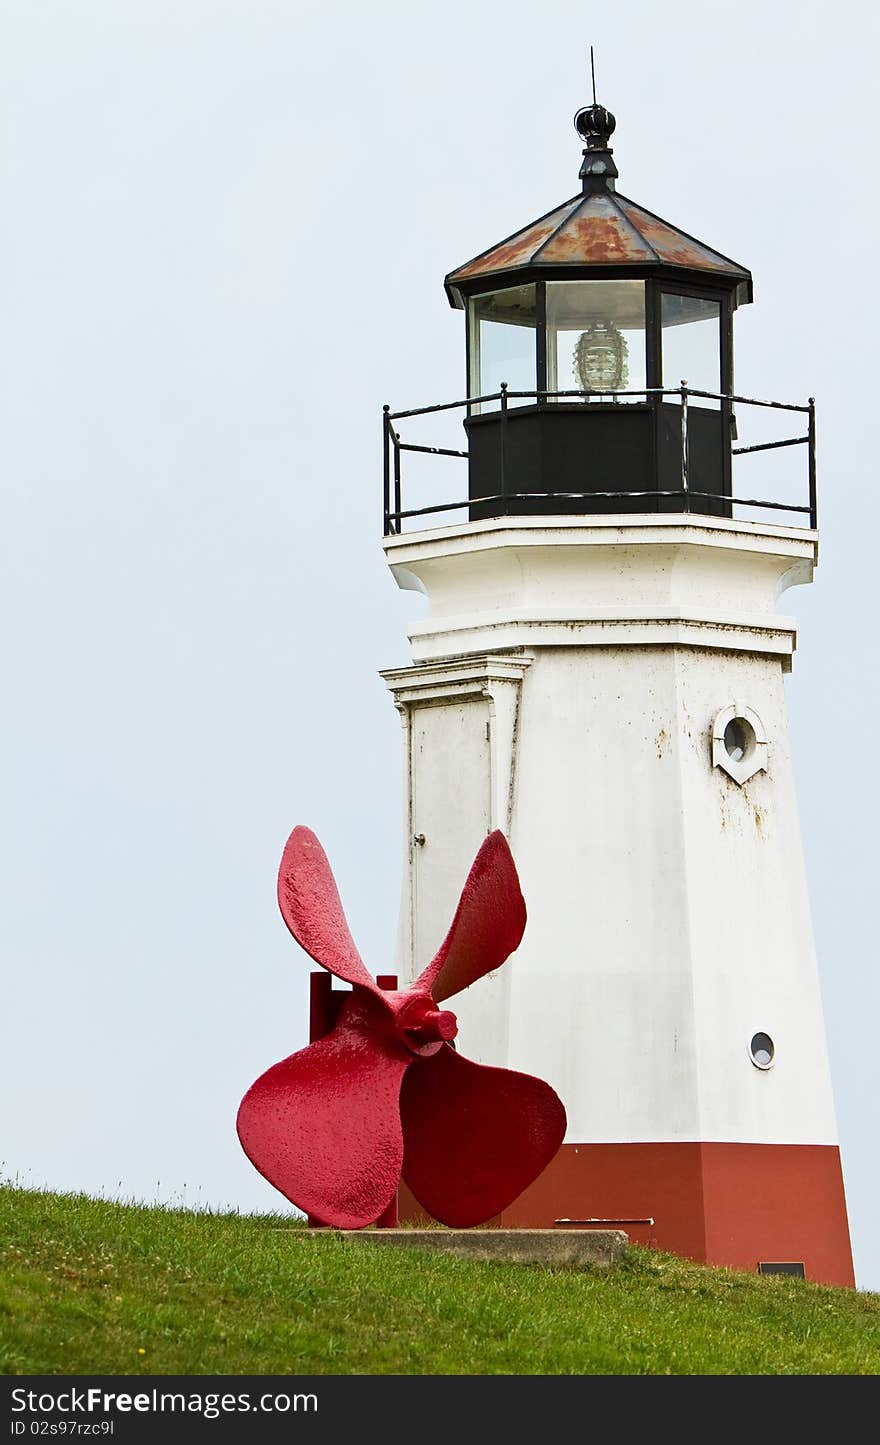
[546,280,644,402]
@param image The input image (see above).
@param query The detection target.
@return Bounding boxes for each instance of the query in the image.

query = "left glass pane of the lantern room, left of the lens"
[468,286,538,412]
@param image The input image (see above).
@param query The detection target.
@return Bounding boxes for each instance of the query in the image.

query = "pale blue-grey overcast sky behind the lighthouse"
[0,0,880,1289]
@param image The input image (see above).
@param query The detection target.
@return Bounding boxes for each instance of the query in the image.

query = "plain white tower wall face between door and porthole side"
[505,647,699,1142]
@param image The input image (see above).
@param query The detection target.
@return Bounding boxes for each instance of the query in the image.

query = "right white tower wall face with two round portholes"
[676,652,837,1143]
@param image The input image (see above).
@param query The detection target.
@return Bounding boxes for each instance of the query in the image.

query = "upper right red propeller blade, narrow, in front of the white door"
[415,829,526,1003]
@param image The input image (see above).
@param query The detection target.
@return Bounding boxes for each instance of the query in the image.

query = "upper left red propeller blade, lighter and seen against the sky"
[277,828,379,993]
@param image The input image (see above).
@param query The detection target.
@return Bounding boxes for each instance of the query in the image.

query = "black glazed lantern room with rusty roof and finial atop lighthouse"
[445,104,751,517]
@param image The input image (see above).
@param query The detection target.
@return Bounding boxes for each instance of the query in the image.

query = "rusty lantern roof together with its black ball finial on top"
[445,104,751,306]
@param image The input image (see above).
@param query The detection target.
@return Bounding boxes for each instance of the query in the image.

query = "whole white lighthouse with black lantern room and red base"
[383,96,854,1285]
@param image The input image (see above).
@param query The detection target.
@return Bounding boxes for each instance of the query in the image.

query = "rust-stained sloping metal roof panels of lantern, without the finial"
[447,188,751,306]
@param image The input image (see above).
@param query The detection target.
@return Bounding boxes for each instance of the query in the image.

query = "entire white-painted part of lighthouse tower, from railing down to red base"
[389,519,835,1143]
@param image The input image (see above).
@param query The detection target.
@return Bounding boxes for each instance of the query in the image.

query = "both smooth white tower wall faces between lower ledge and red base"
[499,647,835,1143]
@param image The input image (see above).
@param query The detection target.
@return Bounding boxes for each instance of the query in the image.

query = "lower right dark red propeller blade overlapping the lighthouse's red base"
[400,1043,565,1230]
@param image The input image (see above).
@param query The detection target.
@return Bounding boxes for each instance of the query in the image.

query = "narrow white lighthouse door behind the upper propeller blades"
[410,696,490,974]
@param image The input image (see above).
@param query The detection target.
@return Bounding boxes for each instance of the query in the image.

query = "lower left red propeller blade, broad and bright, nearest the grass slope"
[237,990,413,1230]
